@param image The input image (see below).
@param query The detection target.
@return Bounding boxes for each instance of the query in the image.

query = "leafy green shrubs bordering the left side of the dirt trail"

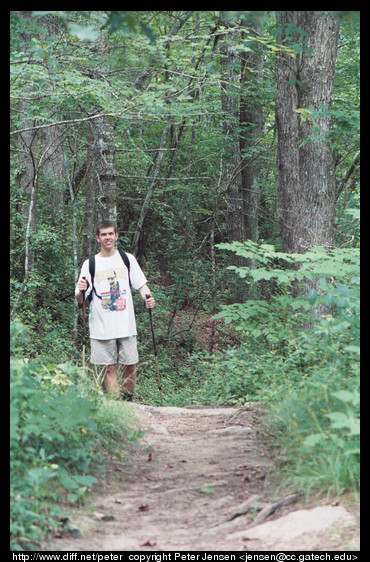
[10,325,140,550]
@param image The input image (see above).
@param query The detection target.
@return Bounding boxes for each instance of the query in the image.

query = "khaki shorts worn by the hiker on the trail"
[91,336,139,365]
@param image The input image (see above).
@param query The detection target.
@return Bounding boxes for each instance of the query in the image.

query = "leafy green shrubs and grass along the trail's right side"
[211,238,360,494]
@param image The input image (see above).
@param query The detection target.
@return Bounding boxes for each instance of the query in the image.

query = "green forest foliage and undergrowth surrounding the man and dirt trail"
[10,11,360,549]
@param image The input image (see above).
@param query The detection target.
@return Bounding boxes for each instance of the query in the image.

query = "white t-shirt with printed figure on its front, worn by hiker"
[76,250,147,340]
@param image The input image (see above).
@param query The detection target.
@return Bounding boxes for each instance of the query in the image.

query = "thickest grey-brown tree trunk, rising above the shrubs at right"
[276,11,339,253]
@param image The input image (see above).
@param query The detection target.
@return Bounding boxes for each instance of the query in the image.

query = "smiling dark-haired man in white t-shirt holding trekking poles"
[76,220,155,400]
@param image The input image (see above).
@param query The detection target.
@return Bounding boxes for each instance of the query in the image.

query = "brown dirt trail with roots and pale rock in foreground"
[43,404,358,552]
